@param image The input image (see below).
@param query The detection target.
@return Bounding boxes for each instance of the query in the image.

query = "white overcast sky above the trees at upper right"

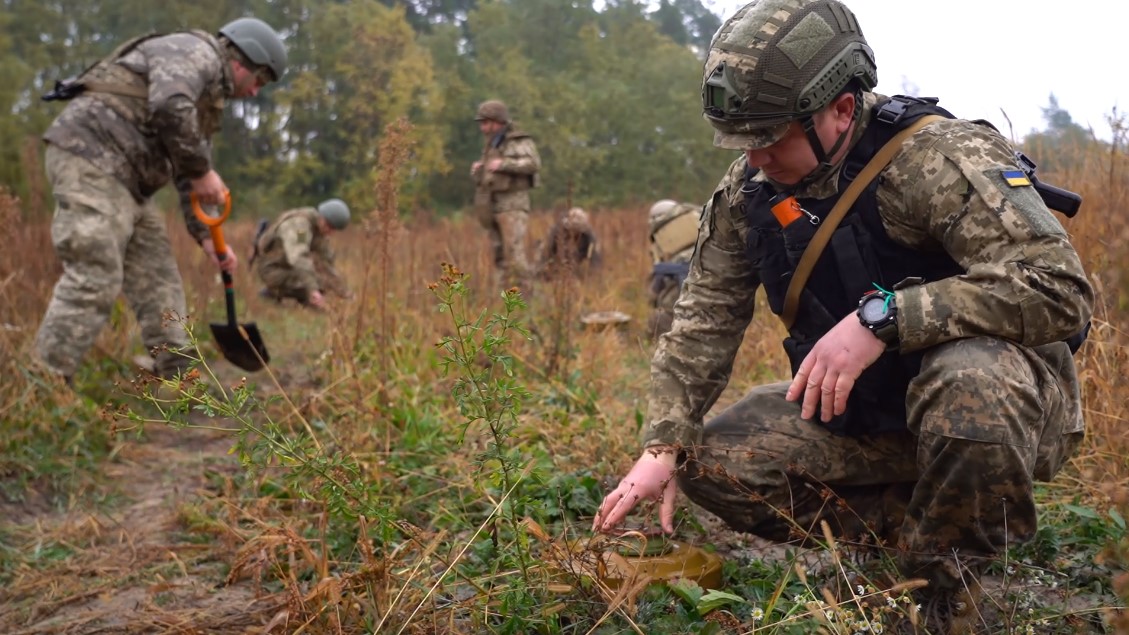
[703,0,1129,140]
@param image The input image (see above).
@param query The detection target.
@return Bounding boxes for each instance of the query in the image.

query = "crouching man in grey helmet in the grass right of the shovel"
[251,199,349,308]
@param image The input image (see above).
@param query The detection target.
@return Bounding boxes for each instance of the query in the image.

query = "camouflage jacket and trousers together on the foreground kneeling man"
[645,93,1094,589]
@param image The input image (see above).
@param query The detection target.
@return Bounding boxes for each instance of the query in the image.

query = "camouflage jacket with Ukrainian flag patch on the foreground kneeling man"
[644,95,1094,446]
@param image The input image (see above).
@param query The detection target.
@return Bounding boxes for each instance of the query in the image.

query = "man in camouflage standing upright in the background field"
[471,101,541,286]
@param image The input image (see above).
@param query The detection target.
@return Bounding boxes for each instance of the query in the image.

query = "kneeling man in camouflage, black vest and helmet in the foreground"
[594,0,1094,634]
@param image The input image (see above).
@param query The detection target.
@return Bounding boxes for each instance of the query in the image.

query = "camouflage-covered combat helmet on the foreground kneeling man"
[702,0,878,153]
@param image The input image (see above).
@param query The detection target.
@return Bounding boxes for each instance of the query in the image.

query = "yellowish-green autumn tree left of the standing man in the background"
[275,0,448,209]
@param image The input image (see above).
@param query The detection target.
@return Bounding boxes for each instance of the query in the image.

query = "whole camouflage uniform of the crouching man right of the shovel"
[254,207,344,304]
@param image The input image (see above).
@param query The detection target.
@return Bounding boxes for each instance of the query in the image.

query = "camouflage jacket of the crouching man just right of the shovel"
[255,207,336,292]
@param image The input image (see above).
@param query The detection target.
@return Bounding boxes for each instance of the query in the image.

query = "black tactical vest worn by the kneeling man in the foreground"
[741,96,964,436]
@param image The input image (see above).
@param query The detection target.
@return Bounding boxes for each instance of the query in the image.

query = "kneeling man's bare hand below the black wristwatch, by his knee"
[786,313,886,423]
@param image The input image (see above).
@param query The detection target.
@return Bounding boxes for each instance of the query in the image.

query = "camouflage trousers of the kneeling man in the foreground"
[677,338,1083,589]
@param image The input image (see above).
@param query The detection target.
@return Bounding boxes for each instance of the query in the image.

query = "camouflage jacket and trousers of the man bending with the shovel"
[36,32,234,377]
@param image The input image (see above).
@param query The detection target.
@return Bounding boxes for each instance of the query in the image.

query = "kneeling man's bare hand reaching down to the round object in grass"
[592,447,676,533]
